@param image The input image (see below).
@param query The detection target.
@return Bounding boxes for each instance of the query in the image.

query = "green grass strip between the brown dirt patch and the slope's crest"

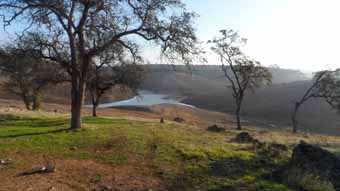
[0,112,338,191]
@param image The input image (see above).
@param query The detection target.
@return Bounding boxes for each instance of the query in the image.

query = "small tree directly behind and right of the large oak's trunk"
[87,41,144,117]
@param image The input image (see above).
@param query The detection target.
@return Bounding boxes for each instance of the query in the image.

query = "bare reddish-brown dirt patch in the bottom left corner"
[0,152,165,191]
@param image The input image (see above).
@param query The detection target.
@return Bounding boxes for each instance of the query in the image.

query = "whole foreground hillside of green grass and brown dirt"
[0,109,340,191]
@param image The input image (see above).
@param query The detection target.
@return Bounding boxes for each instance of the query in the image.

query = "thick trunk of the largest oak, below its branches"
[71,74,86,129]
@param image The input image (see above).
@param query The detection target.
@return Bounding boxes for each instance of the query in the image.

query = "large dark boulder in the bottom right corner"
[289,141,340,190]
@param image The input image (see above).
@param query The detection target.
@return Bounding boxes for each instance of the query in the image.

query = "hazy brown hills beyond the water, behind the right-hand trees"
[142,65,340,134]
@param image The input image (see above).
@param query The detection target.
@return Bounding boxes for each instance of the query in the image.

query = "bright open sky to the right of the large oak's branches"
[184,0,340,71]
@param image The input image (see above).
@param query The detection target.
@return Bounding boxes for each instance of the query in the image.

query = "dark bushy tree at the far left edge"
[0,47,66,111]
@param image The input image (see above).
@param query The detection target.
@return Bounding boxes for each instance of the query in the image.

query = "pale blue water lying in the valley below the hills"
[98,90,194,108]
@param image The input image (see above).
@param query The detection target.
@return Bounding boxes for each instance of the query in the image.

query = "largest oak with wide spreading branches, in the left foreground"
[0,0,202,128]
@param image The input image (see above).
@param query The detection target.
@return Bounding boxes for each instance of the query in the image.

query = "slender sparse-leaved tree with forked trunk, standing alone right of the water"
[208,30,272,130]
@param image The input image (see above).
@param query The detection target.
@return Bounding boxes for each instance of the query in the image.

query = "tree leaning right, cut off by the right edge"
[292,69,340,133]
